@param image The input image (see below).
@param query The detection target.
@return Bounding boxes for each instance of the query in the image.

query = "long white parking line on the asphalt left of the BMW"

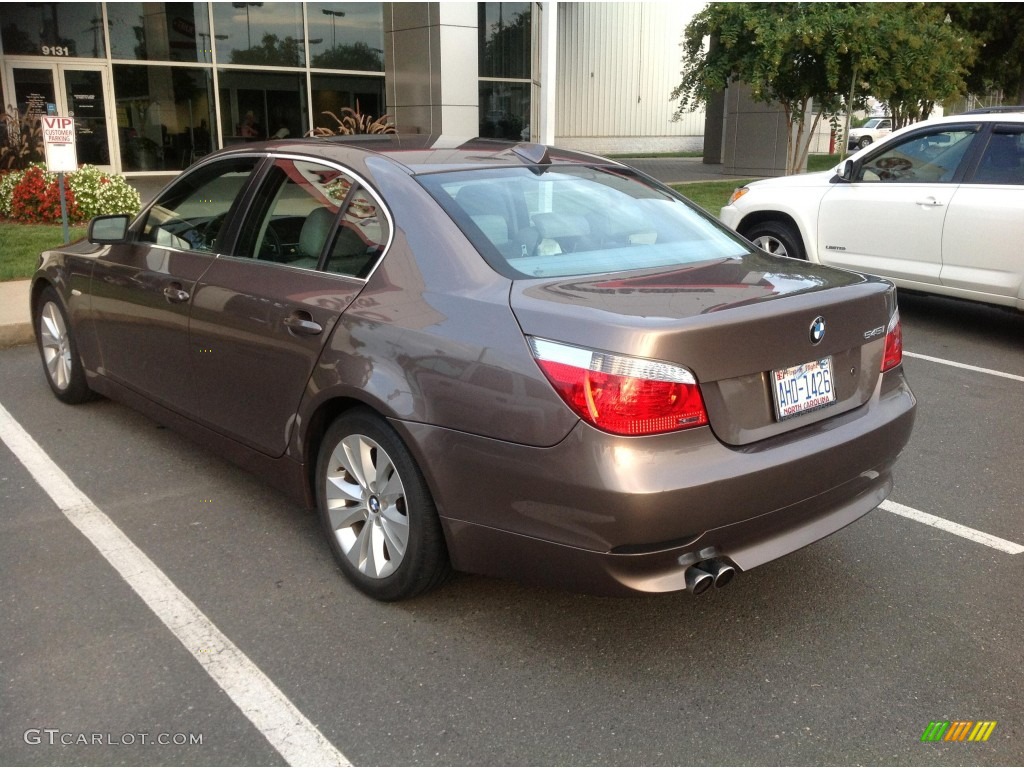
[0,404,351,766]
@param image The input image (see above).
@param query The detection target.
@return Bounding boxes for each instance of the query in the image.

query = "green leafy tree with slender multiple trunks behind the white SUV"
[672,3,973,173]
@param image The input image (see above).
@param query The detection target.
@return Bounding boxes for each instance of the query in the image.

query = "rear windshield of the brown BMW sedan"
[418,166,750,279]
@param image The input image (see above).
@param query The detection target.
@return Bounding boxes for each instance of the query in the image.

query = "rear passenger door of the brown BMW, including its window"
[190,158,390,456]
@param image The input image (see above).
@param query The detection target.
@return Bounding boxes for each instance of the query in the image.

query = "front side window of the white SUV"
[856,128,976,183]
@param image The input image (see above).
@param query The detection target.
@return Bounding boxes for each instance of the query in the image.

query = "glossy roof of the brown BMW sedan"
[201,133,622,174]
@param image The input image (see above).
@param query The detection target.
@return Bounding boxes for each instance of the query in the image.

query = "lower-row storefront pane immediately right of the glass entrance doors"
[114,65,214,171]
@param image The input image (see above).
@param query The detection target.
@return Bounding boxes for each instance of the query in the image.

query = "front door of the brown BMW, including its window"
[92,157,260,413]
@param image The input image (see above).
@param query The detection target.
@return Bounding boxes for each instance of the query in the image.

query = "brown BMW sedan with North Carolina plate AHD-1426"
[32,136,915,600]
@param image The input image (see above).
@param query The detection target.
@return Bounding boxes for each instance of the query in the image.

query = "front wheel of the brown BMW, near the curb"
[33,287,93,404]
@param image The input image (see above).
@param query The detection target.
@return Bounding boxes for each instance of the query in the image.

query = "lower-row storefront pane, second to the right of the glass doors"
[217,70,309,146]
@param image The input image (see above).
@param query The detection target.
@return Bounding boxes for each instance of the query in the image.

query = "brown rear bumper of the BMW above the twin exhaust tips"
[396,370,915,594]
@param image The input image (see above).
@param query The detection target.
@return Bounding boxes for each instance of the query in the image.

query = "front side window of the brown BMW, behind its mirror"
[139,158,259,253]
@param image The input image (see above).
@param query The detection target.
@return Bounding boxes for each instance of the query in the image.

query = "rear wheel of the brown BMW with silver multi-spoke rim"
[316,409,452,601]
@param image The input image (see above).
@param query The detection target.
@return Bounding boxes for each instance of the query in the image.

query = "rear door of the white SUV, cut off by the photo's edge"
[941,123,1024,304]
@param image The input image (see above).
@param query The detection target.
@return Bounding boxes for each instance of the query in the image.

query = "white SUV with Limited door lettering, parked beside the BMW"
[720,113,1024,310]
